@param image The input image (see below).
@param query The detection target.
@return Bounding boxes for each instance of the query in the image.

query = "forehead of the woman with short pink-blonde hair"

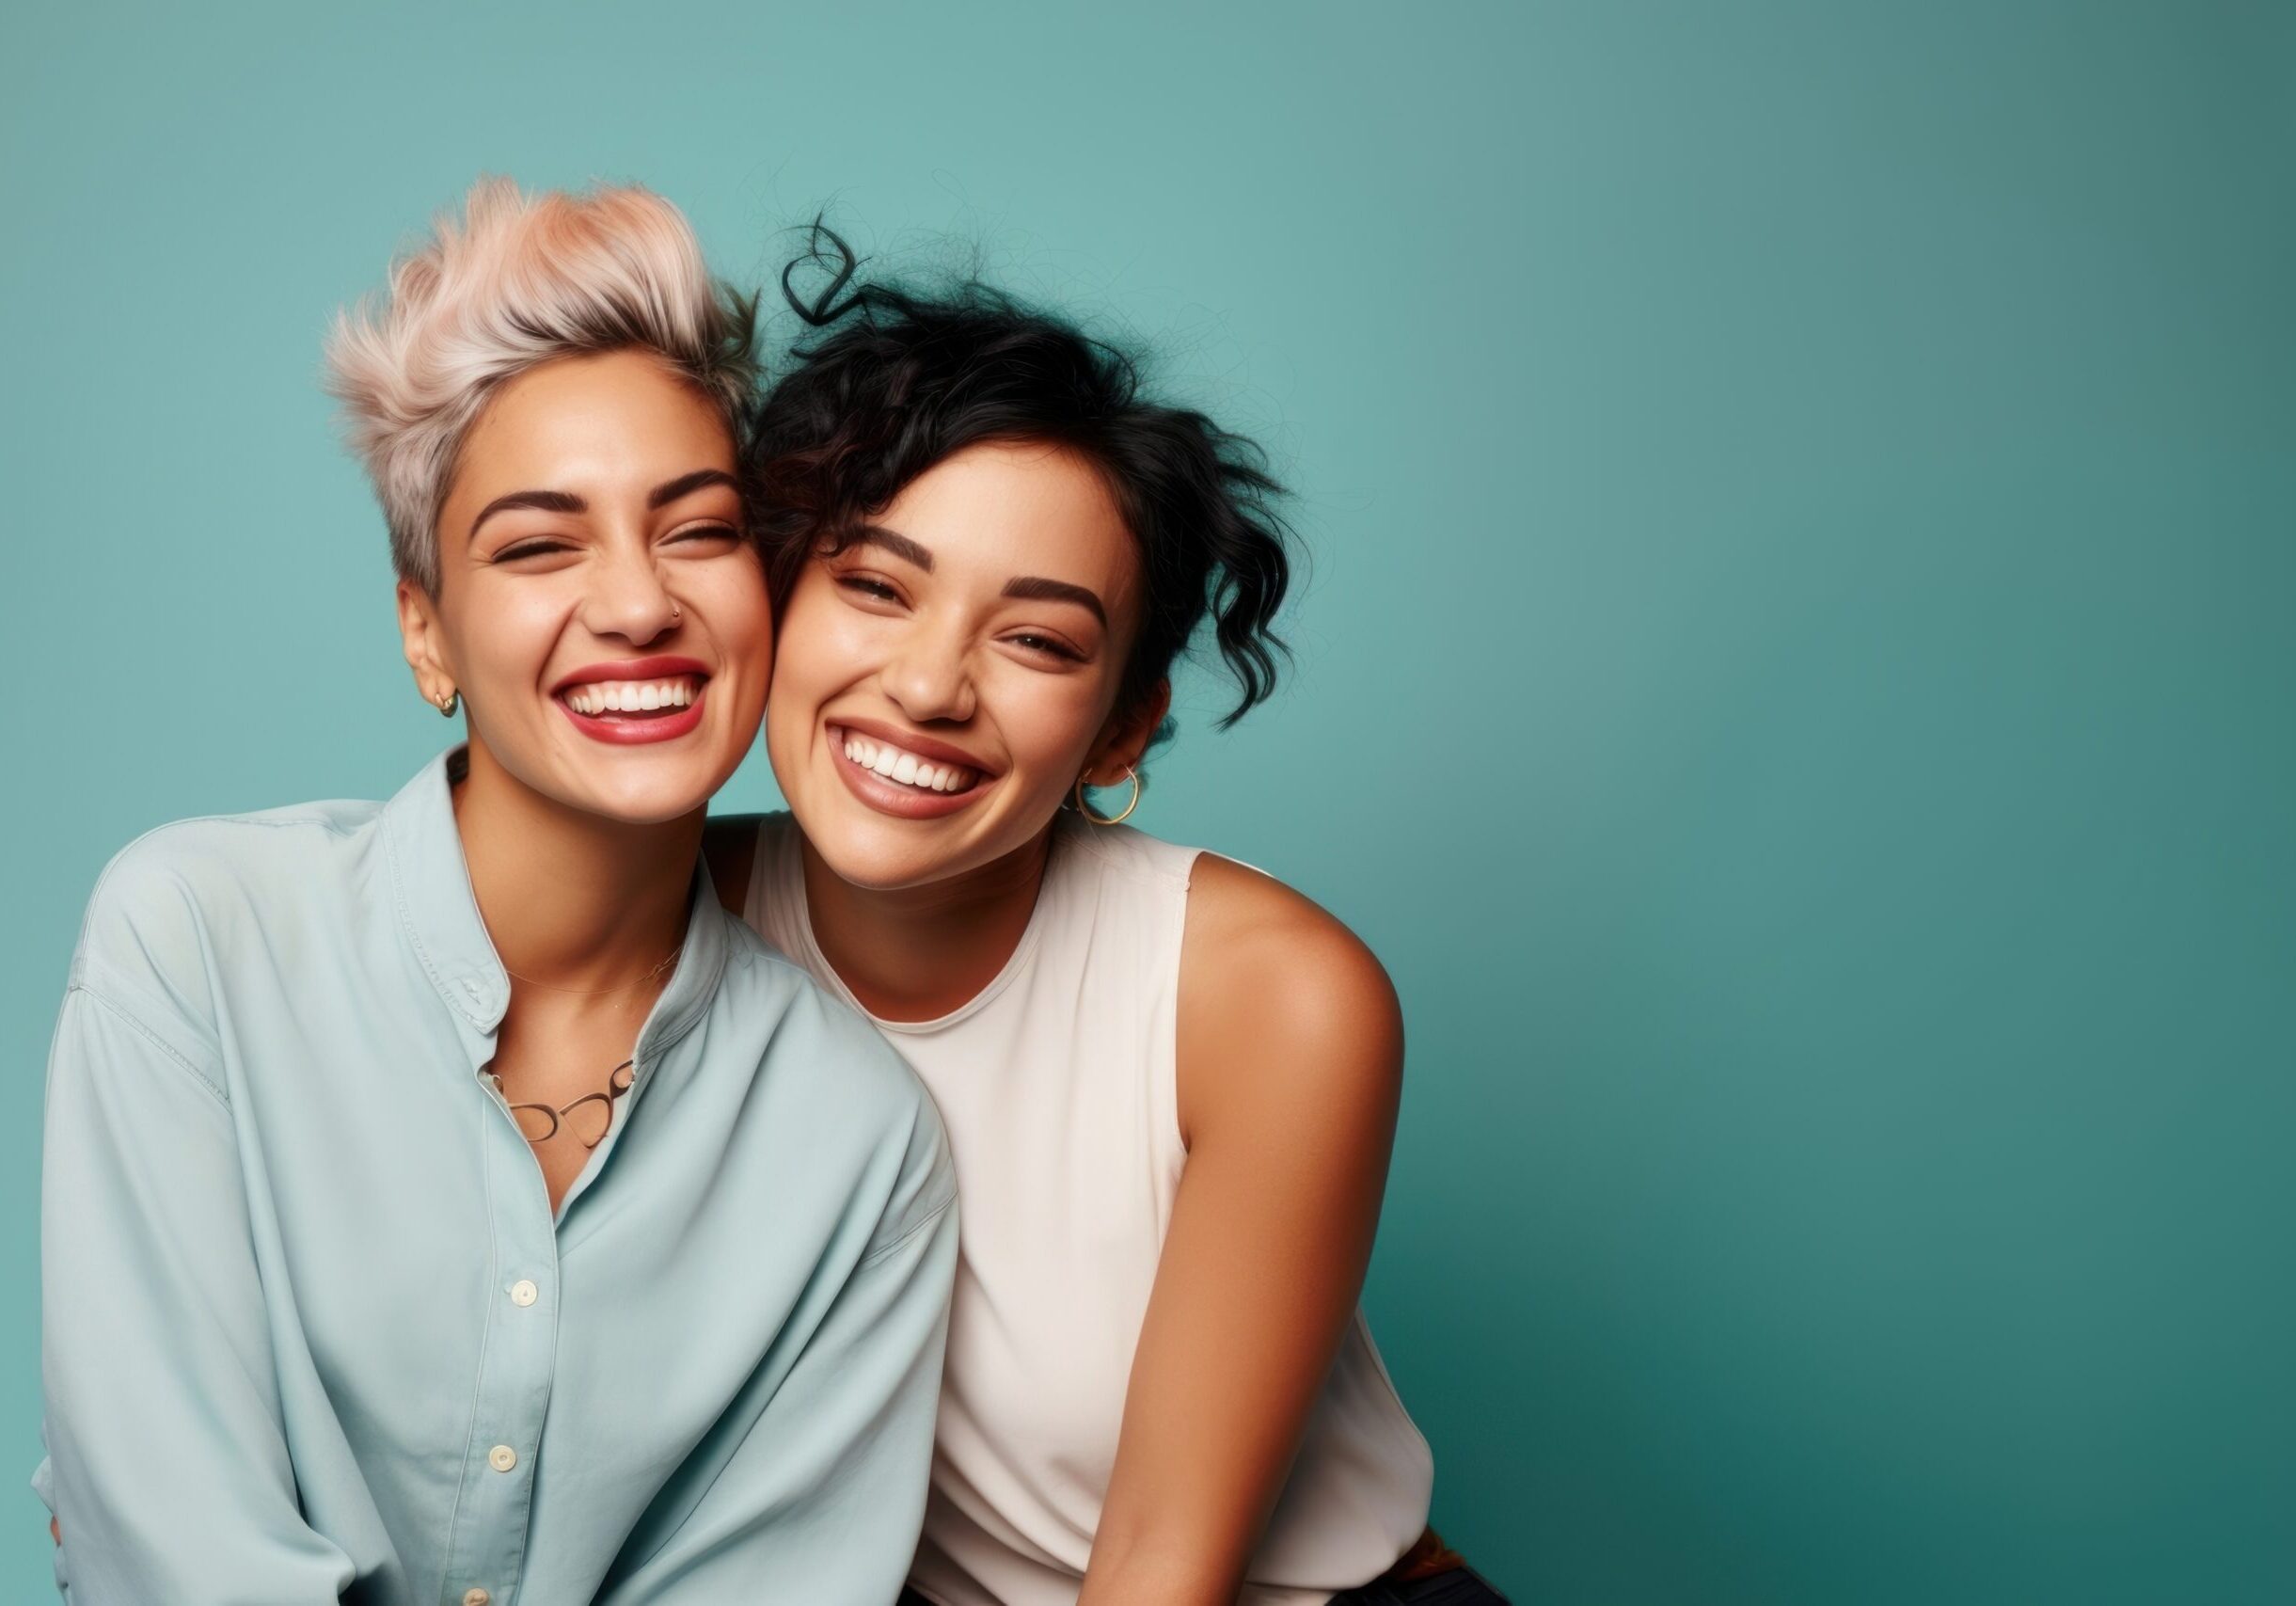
[448,352,733,501]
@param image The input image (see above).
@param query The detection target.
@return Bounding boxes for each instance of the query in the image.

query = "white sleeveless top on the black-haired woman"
[744,813,1435,1606]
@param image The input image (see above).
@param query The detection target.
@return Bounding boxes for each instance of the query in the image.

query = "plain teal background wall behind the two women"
[0,0,2296,1606]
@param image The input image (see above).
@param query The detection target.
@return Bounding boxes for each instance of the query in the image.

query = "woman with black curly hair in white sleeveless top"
[712,230,1499,1606]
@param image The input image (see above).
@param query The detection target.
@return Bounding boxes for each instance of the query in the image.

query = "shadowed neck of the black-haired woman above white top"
[799,827,1052,1020]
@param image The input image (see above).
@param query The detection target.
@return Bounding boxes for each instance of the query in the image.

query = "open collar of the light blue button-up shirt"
[384,747,733,1052]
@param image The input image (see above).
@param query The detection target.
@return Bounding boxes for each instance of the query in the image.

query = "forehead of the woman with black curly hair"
[877,441,1139,602]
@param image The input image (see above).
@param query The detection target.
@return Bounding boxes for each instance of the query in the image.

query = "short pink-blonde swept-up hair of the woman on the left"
[326,179,758,591]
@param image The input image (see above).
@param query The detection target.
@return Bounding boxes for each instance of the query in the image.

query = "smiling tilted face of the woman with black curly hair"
[765,443,1162,889]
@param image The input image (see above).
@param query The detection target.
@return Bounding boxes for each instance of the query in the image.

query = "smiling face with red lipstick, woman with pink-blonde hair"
[400,352,774,825]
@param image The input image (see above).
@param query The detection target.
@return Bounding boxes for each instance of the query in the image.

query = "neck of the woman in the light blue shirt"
[454,739,705,993]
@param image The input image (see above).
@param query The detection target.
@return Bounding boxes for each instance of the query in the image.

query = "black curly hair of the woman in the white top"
[746,223,1291,735]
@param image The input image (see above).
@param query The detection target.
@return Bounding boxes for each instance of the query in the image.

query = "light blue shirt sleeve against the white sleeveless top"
[597,1103,958,1606]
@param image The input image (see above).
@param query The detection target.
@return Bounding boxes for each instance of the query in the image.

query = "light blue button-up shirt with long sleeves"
[37,755,958,1606]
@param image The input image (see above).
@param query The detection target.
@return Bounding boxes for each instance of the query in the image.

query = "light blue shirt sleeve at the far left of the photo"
[41,974,351,1606]
